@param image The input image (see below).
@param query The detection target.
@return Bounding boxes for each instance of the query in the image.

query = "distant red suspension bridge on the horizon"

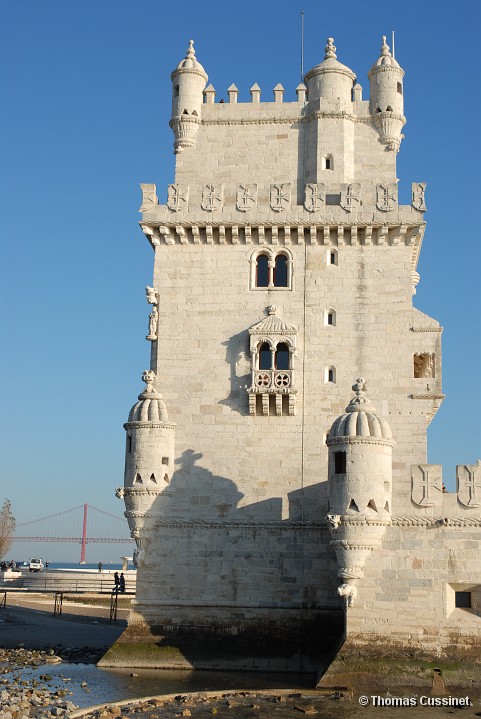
[13,504,134,564]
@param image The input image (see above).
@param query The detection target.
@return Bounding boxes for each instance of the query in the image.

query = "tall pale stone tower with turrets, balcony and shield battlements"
[109,33,481,671]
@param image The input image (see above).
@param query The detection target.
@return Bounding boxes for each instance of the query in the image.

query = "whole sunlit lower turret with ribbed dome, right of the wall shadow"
[326,377,394,605]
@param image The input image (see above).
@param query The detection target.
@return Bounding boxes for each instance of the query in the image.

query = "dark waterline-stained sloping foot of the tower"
[99,606,344,681]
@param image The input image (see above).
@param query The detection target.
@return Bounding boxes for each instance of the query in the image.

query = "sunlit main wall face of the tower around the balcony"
[149,239,426,521]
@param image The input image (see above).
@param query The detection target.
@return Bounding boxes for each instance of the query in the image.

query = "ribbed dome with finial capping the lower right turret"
[327,377,392,444]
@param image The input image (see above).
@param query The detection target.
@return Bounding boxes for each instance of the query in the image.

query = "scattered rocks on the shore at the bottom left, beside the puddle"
[0,645,104,719]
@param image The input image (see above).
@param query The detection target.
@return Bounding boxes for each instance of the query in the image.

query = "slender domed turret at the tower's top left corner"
[170,40,208,153]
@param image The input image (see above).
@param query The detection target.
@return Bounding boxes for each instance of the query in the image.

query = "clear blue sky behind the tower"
[0,0,481,562]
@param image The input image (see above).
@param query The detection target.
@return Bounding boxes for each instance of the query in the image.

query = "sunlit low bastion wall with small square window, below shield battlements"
[347,523,481,658]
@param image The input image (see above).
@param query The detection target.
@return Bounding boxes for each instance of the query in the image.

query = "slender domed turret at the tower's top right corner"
[368,35,406,152]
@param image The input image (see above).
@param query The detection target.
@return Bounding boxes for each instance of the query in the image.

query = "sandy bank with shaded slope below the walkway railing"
[0,592,128,649]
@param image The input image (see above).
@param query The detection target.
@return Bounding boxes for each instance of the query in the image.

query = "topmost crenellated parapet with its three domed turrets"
[170,37,406,153]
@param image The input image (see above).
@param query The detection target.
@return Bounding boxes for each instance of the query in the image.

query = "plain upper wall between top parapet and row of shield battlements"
[175,101,396,191]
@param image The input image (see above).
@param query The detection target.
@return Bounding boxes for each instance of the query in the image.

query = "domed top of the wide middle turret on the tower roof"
[304,37,356,110]
